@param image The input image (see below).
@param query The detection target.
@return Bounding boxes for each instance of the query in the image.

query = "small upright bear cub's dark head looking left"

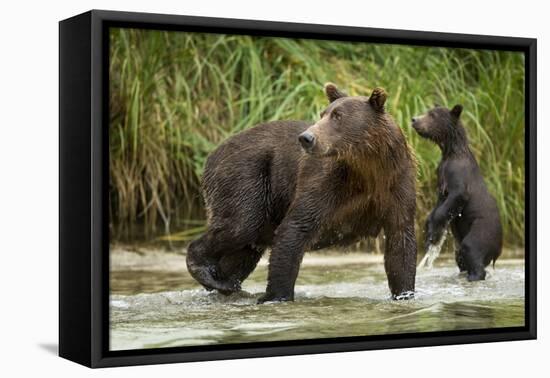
[412,105,465,149]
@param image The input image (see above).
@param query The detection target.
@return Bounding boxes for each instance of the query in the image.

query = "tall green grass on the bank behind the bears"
[109,29,525,245]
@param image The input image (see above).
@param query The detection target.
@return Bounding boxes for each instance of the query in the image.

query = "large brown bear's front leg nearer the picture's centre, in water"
[258,207,320,303]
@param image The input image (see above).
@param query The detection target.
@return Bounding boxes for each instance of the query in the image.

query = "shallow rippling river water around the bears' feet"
[110,254,524,350]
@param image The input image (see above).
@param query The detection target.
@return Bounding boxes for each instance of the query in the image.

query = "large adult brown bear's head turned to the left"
[298,83,396,157]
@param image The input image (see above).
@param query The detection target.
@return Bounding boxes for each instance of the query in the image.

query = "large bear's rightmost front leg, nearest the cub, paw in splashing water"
[384,222,416,299]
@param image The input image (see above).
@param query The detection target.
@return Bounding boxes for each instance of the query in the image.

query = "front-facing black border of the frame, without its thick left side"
[60,10,536,367]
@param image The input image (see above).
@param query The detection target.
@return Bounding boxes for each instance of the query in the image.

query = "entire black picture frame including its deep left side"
[59,10,537,367]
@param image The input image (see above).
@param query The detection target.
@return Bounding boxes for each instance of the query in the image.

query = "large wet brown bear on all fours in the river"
[187,84,416,303]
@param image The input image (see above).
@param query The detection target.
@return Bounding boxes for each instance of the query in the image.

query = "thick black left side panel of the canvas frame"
[58,12,94,366]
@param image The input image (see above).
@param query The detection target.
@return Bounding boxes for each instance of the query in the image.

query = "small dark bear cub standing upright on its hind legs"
[412,105,502,281]
